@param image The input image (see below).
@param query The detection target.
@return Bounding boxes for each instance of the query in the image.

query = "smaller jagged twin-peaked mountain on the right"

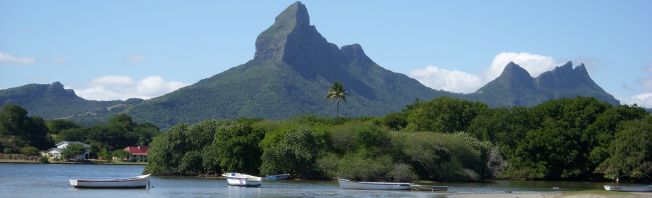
[467,62,620,106]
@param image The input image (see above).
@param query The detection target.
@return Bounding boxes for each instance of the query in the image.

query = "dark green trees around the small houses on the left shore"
[0,104,160,160]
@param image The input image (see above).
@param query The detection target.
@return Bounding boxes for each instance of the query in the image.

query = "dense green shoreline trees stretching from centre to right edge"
[145,97,652,181]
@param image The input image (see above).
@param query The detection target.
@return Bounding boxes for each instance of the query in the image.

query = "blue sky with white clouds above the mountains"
[0,0,652,107]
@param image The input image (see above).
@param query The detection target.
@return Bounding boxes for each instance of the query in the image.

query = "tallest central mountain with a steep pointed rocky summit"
[129,2,455,126]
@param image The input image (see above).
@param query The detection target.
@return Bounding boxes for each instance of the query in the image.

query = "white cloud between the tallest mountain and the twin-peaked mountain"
[410,65,483,93]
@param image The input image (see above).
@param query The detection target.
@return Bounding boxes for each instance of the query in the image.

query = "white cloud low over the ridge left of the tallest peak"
[76,75,188,100]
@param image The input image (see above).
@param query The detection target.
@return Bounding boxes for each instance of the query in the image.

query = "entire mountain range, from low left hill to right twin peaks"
[0,2,619,128]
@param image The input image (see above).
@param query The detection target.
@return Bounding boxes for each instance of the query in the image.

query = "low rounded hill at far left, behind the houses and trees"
[0,82,142,119]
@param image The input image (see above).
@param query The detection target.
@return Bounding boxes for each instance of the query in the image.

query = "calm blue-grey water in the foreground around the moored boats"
[0,164,604,198]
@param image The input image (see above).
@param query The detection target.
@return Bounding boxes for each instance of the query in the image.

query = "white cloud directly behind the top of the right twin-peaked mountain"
[484,52,563,81]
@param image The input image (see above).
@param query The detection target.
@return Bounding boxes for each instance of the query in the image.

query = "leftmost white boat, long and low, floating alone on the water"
[69,174,149,188]
